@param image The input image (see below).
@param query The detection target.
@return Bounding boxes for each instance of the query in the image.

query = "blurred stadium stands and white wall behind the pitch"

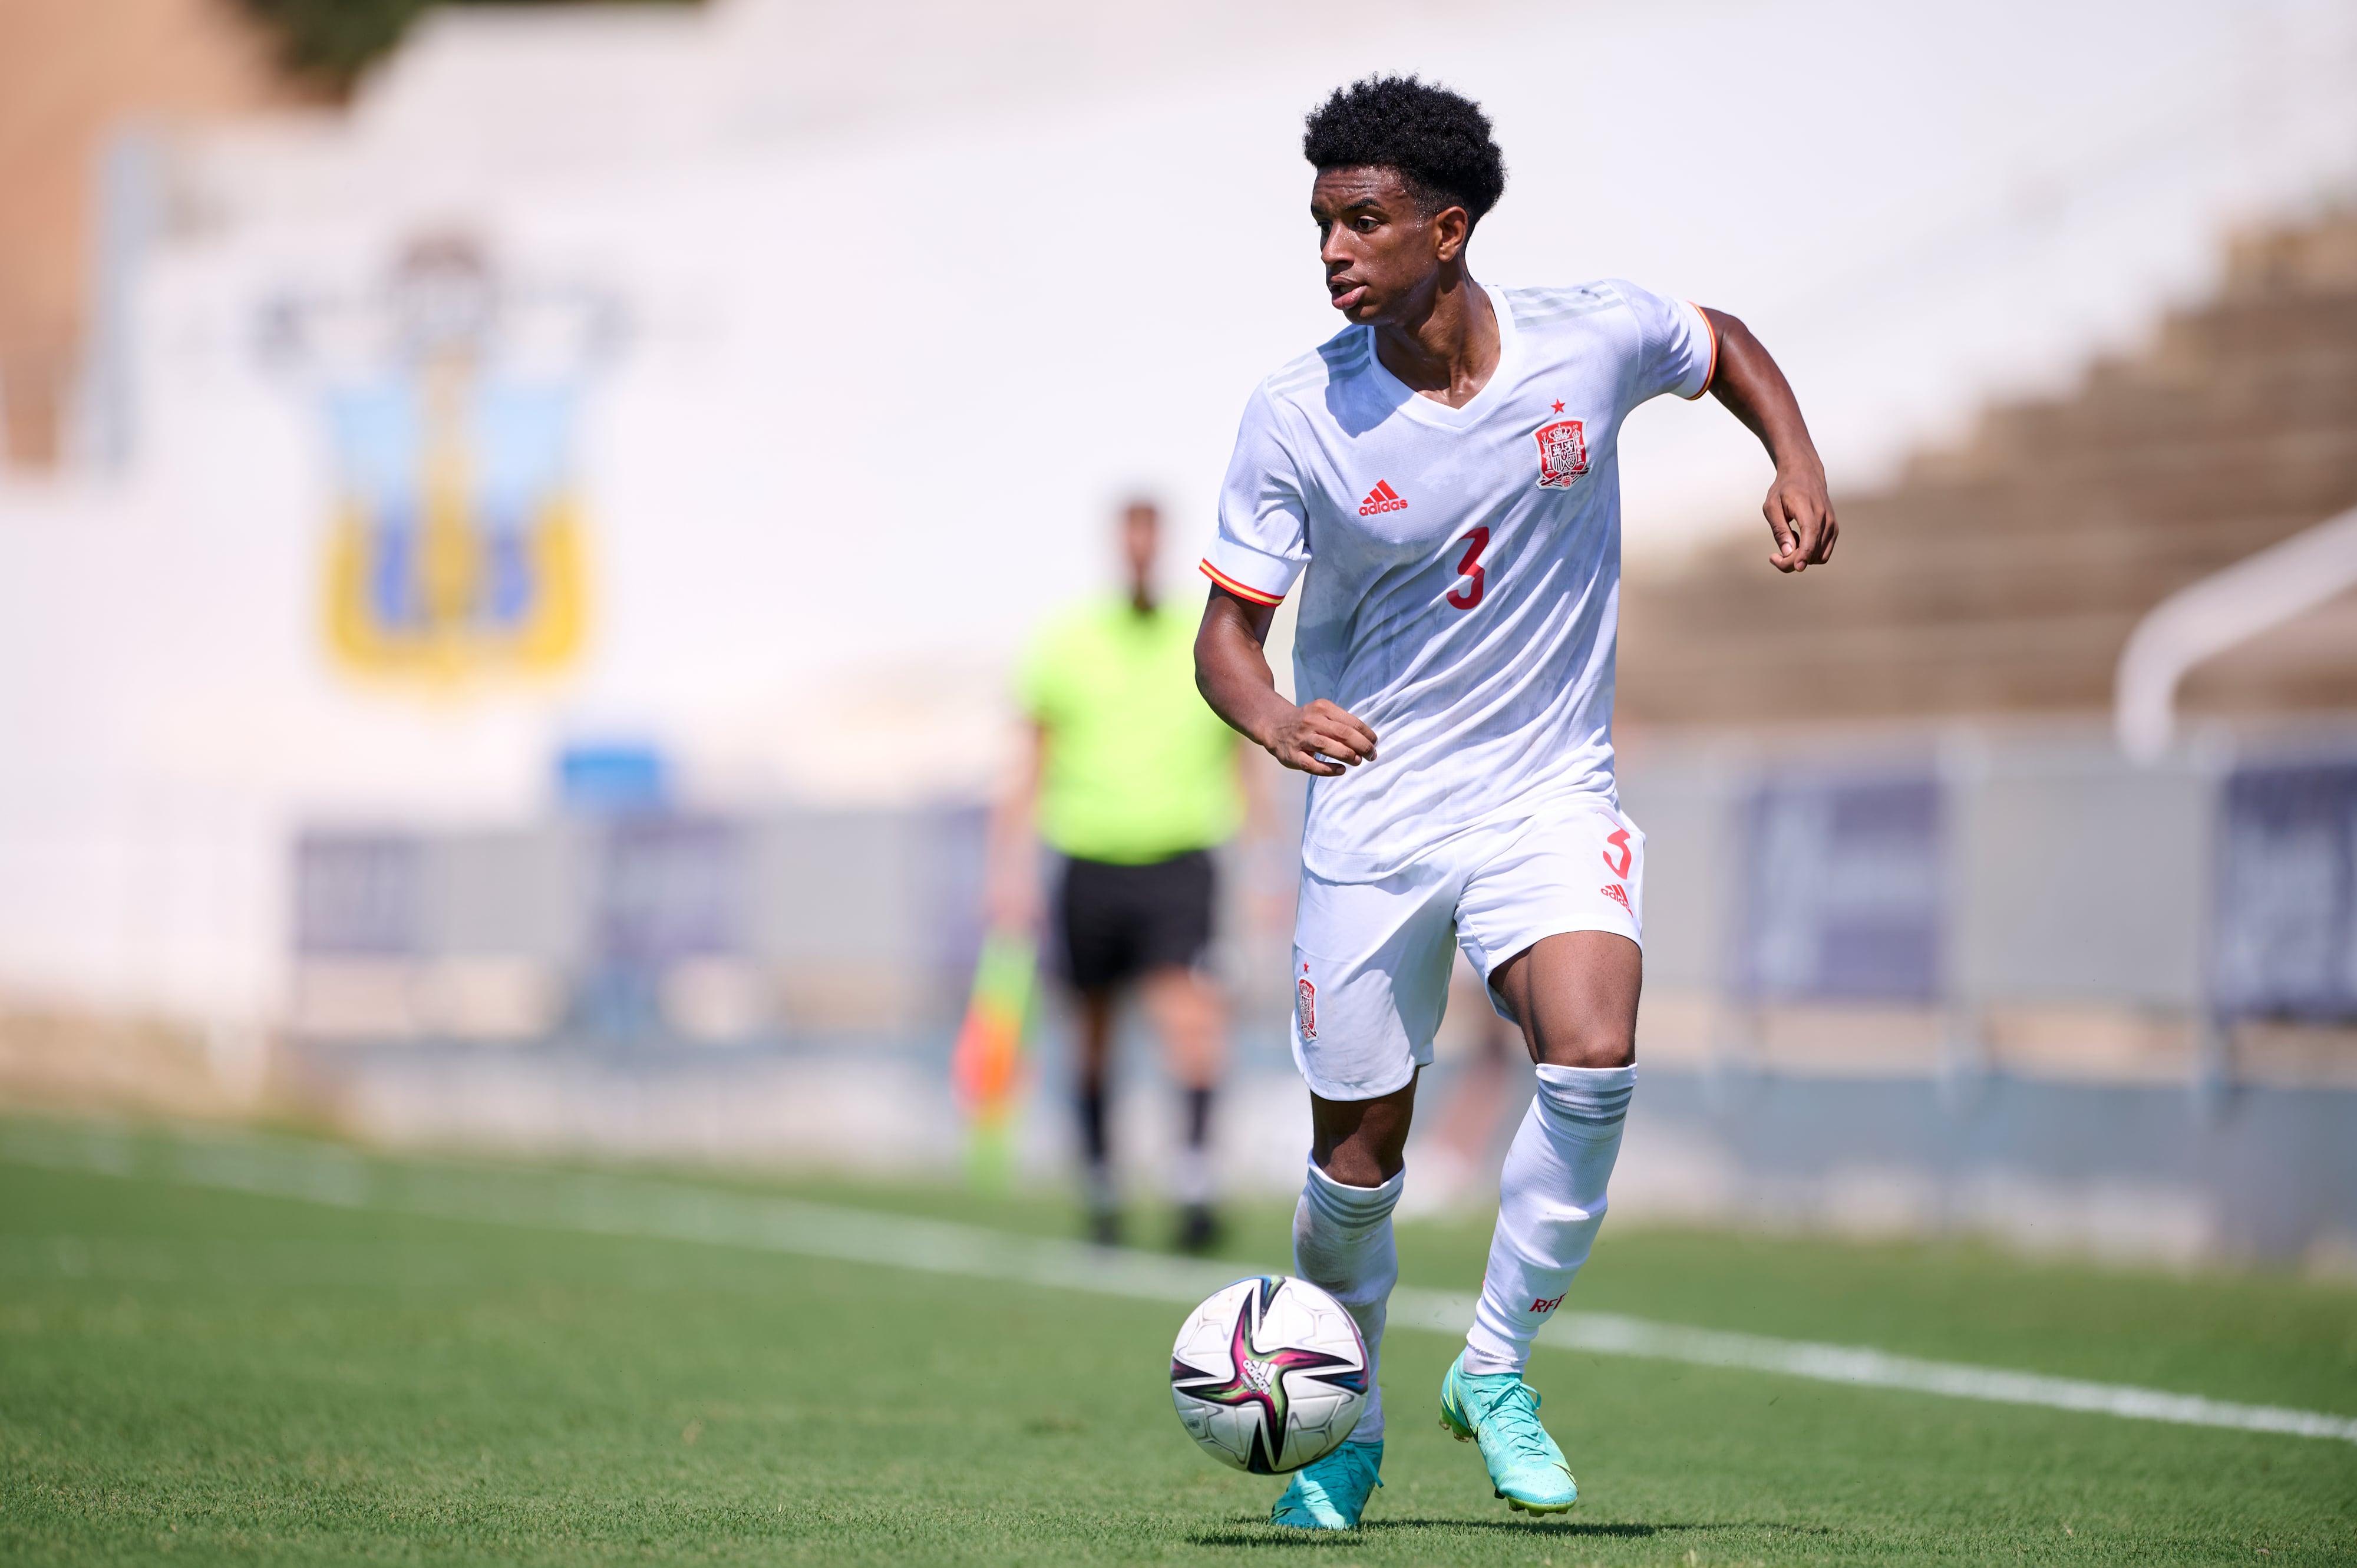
[0,0,2357,1271]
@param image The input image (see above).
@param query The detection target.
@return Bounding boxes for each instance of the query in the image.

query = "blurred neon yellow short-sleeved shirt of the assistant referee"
[1021,599,1242,866]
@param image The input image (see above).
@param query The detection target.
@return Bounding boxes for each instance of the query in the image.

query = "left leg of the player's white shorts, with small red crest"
[1294,868,1454,1101]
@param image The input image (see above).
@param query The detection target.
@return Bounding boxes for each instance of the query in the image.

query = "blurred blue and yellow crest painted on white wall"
[266,236,618,684]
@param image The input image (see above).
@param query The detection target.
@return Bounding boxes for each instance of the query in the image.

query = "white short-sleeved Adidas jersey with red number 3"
[1202,280,1718,882]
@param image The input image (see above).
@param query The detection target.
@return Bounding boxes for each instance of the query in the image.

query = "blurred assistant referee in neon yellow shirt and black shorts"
[990,500,1244,1250]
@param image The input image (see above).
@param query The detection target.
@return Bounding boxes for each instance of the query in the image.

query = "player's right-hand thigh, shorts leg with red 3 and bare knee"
[1457,802,1645,1066]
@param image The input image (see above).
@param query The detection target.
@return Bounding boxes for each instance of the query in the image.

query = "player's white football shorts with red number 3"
[1294,797,1645,1099]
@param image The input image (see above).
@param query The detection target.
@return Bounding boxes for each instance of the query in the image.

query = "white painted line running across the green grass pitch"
[0,1123,2357,1443]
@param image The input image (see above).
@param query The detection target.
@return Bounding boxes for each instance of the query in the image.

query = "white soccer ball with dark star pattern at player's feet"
[1171,1273,1367,1476]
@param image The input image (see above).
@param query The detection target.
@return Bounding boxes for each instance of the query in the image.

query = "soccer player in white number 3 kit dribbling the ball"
[1195,78,1836,1530]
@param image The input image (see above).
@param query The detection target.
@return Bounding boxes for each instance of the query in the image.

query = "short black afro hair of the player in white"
[1301,75,1506,224]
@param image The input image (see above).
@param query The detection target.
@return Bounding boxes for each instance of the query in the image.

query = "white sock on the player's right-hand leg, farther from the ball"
[1466,1064,1636,1375]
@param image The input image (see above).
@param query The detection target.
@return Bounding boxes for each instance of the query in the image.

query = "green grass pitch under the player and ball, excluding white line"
[0,1113,2357,1568]
